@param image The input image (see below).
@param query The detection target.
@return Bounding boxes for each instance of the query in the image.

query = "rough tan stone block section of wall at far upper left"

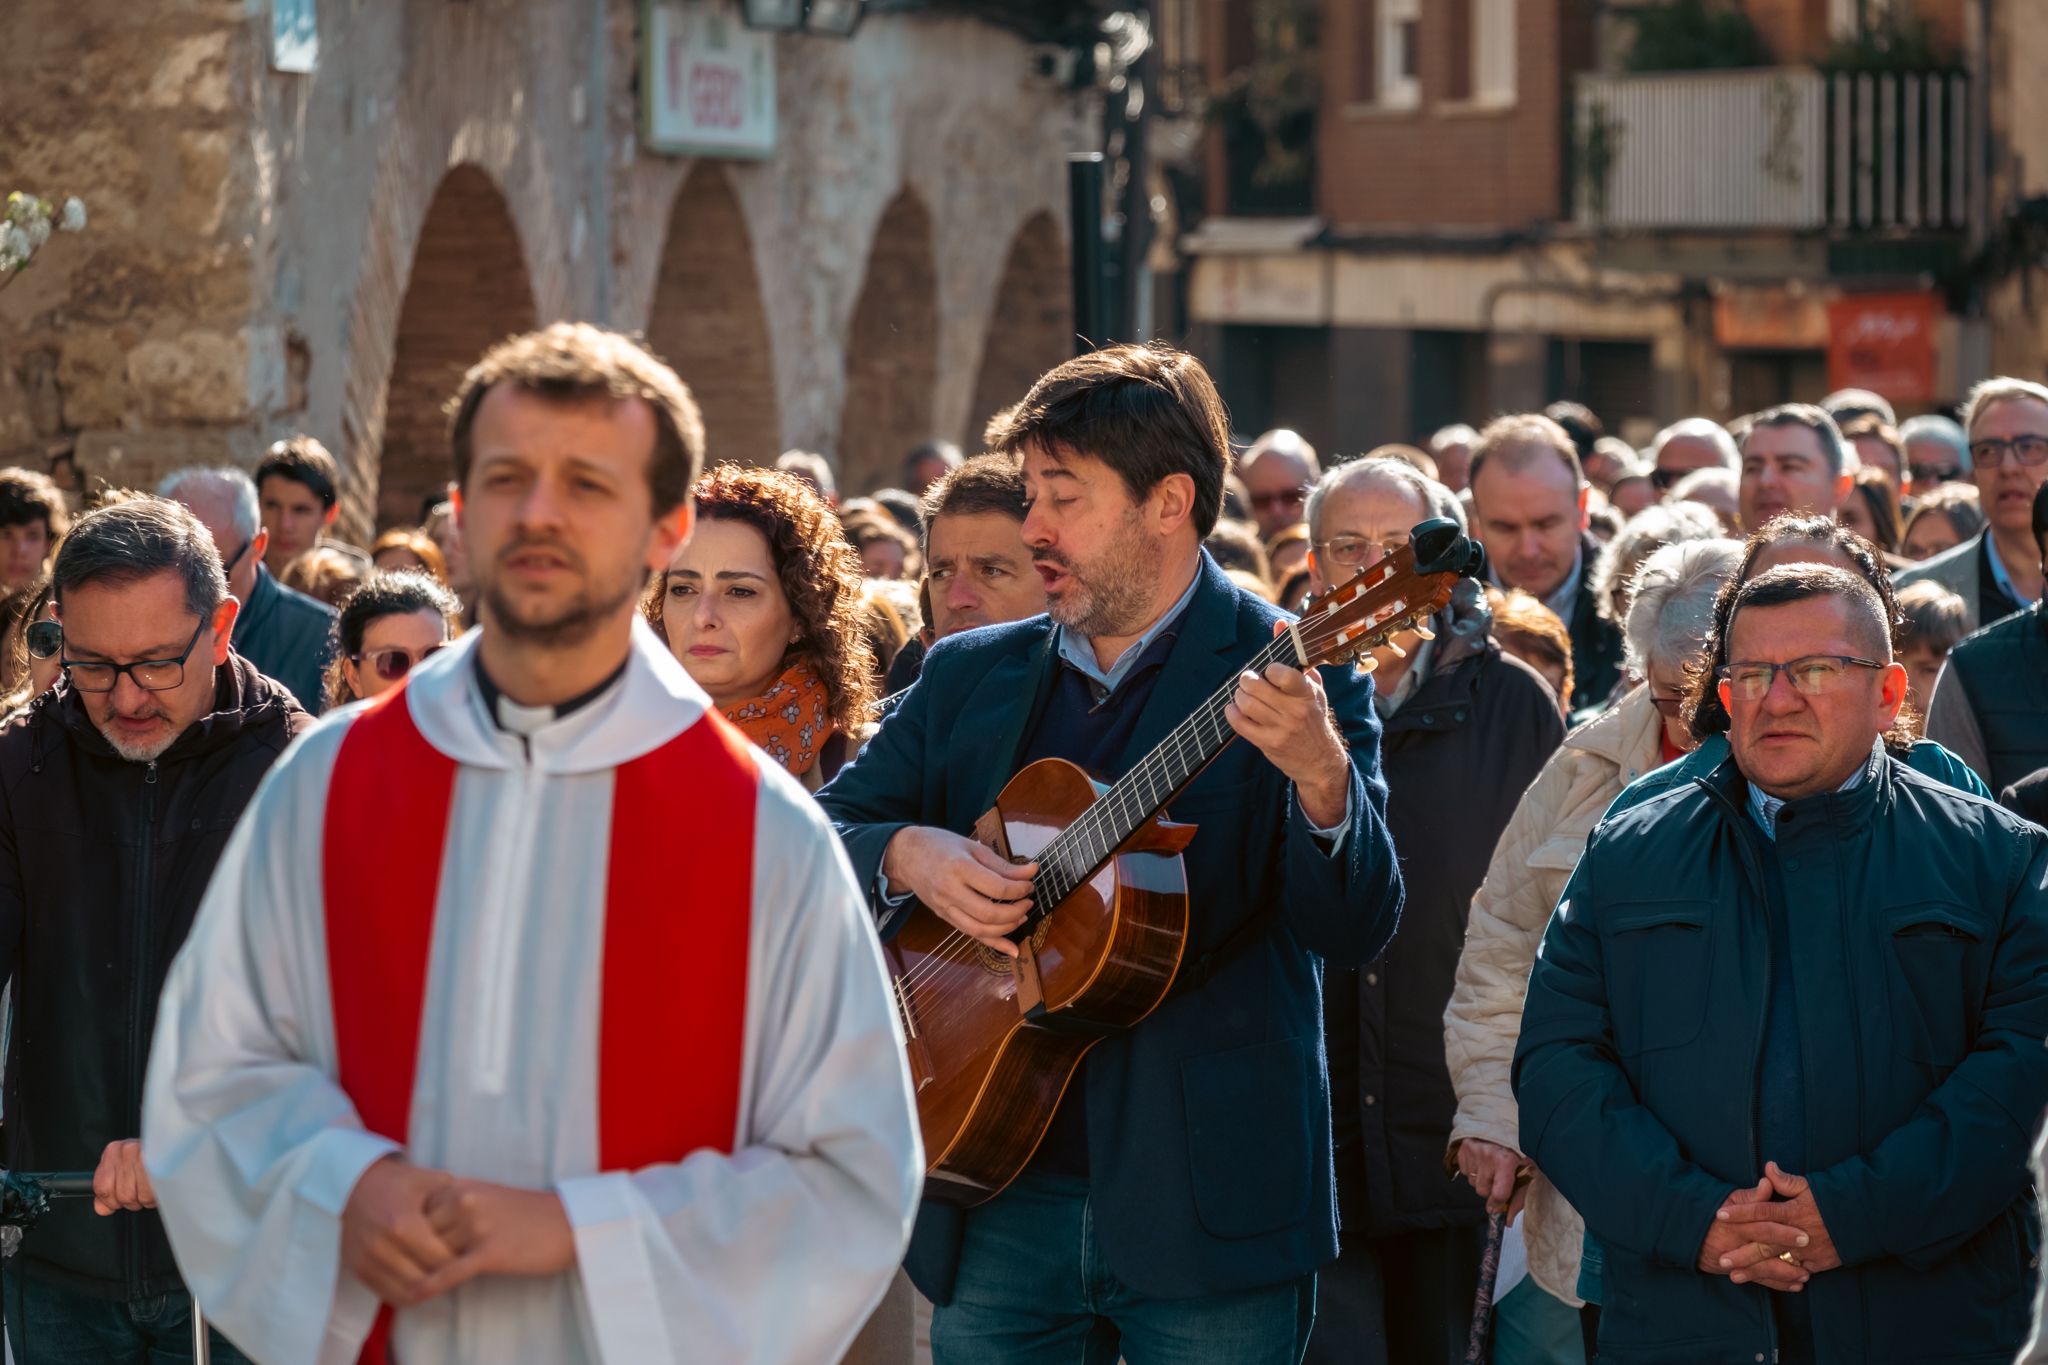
[0,0,268,501]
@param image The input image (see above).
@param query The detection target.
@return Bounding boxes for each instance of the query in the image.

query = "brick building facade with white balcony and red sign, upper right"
[1186,0,2048,452]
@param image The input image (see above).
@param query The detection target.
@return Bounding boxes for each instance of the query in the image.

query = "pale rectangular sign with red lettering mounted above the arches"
[641,0,774,158]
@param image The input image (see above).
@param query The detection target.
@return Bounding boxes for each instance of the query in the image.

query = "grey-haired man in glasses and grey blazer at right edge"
[1896,377,2048,630]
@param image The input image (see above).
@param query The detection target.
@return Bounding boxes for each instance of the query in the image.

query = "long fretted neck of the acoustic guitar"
[1032,634,1296,919]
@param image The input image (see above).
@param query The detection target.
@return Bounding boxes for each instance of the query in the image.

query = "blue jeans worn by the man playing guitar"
[932,1175,1315,1365]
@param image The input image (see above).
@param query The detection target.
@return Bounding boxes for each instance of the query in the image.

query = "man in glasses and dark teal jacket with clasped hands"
[1513,565,2048,1365]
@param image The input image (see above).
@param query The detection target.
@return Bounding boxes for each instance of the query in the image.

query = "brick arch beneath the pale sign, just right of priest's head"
[647,164,782,465]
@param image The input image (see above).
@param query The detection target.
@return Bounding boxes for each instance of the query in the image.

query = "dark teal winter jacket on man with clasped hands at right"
[1513,755,2048,1365]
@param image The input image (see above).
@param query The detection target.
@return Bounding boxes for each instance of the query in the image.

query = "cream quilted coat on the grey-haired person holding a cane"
[1444,688,1663,1308]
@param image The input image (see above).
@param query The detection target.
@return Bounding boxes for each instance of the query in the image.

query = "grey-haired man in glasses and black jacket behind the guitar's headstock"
[1303,456,1565,1365]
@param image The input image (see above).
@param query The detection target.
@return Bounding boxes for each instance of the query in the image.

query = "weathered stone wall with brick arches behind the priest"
[0,0,1094,534]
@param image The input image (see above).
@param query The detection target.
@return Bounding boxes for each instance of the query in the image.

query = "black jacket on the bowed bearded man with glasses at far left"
[0,655,311,1300]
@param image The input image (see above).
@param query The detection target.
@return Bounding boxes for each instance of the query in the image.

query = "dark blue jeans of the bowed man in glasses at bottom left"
[0,1269,250,1365]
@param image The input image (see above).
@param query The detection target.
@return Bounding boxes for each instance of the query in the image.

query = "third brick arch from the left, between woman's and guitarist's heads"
[840,190,938,493]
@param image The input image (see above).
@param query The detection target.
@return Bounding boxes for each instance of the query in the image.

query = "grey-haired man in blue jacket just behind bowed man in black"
[156,467,334,716]
